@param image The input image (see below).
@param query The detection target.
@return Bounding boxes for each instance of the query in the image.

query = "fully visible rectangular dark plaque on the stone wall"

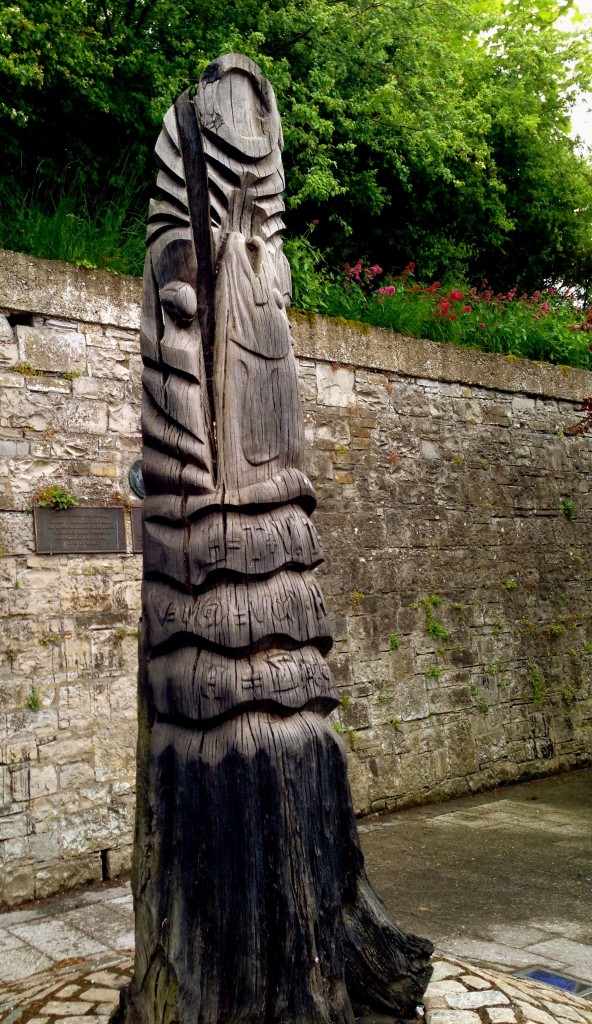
[34,508,127,555]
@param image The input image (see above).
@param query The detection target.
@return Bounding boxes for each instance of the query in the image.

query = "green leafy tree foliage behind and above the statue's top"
[0,0,592,288]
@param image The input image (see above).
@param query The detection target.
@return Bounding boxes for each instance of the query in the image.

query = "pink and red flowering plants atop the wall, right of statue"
[293,249,592,370]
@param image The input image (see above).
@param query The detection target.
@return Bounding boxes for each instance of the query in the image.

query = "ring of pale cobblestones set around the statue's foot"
[0,956,592,1024]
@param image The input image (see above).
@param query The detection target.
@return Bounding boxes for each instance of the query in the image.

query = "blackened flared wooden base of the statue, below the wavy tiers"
[114,711,432,1024]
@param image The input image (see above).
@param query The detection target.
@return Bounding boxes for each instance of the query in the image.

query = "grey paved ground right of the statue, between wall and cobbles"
[360,769,592,984]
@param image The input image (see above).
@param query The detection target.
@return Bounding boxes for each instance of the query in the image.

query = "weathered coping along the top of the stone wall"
[0,249,592,401]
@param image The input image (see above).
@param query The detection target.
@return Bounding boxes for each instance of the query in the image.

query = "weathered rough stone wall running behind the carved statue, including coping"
[0,252,592,904]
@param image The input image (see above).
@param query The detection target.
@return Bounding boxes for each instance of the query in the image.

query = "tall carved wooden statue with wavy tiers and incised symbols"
[116,55,431,1024]
